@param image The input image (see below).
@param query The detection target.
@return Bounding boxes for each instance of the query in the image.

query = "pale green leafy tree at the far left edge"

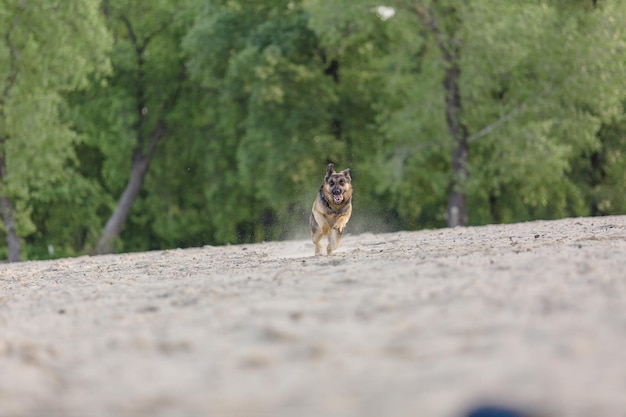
[0,0,110,261]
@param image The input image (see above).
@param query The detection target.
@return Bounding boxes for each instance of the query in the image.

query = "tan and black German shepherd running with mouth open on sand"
[309,163,352,255]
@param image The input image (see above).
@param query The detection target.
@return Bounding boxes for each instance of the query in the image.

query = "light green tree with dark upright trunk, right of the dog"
[383,0,624,225]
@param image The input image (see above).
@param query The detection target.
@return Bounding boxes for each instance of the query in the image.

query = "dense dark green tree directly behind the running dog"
[184,0,394,242]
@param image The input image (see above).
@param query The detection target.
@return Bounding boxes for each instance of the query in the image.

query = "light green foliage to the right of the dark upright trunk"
[464,2,626,223]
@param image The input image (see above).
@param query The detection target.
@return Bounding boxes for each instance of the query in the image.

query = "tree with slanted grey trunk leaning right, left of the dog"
[90,0,195,253]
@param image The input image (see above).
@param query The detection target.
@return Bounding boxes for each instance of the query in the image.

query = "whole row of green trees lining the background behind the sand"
[0,0,626,261]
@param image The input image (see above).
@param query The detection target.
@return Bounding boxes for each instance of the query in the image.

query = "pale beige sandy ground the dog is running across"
[0,216,626,417]
